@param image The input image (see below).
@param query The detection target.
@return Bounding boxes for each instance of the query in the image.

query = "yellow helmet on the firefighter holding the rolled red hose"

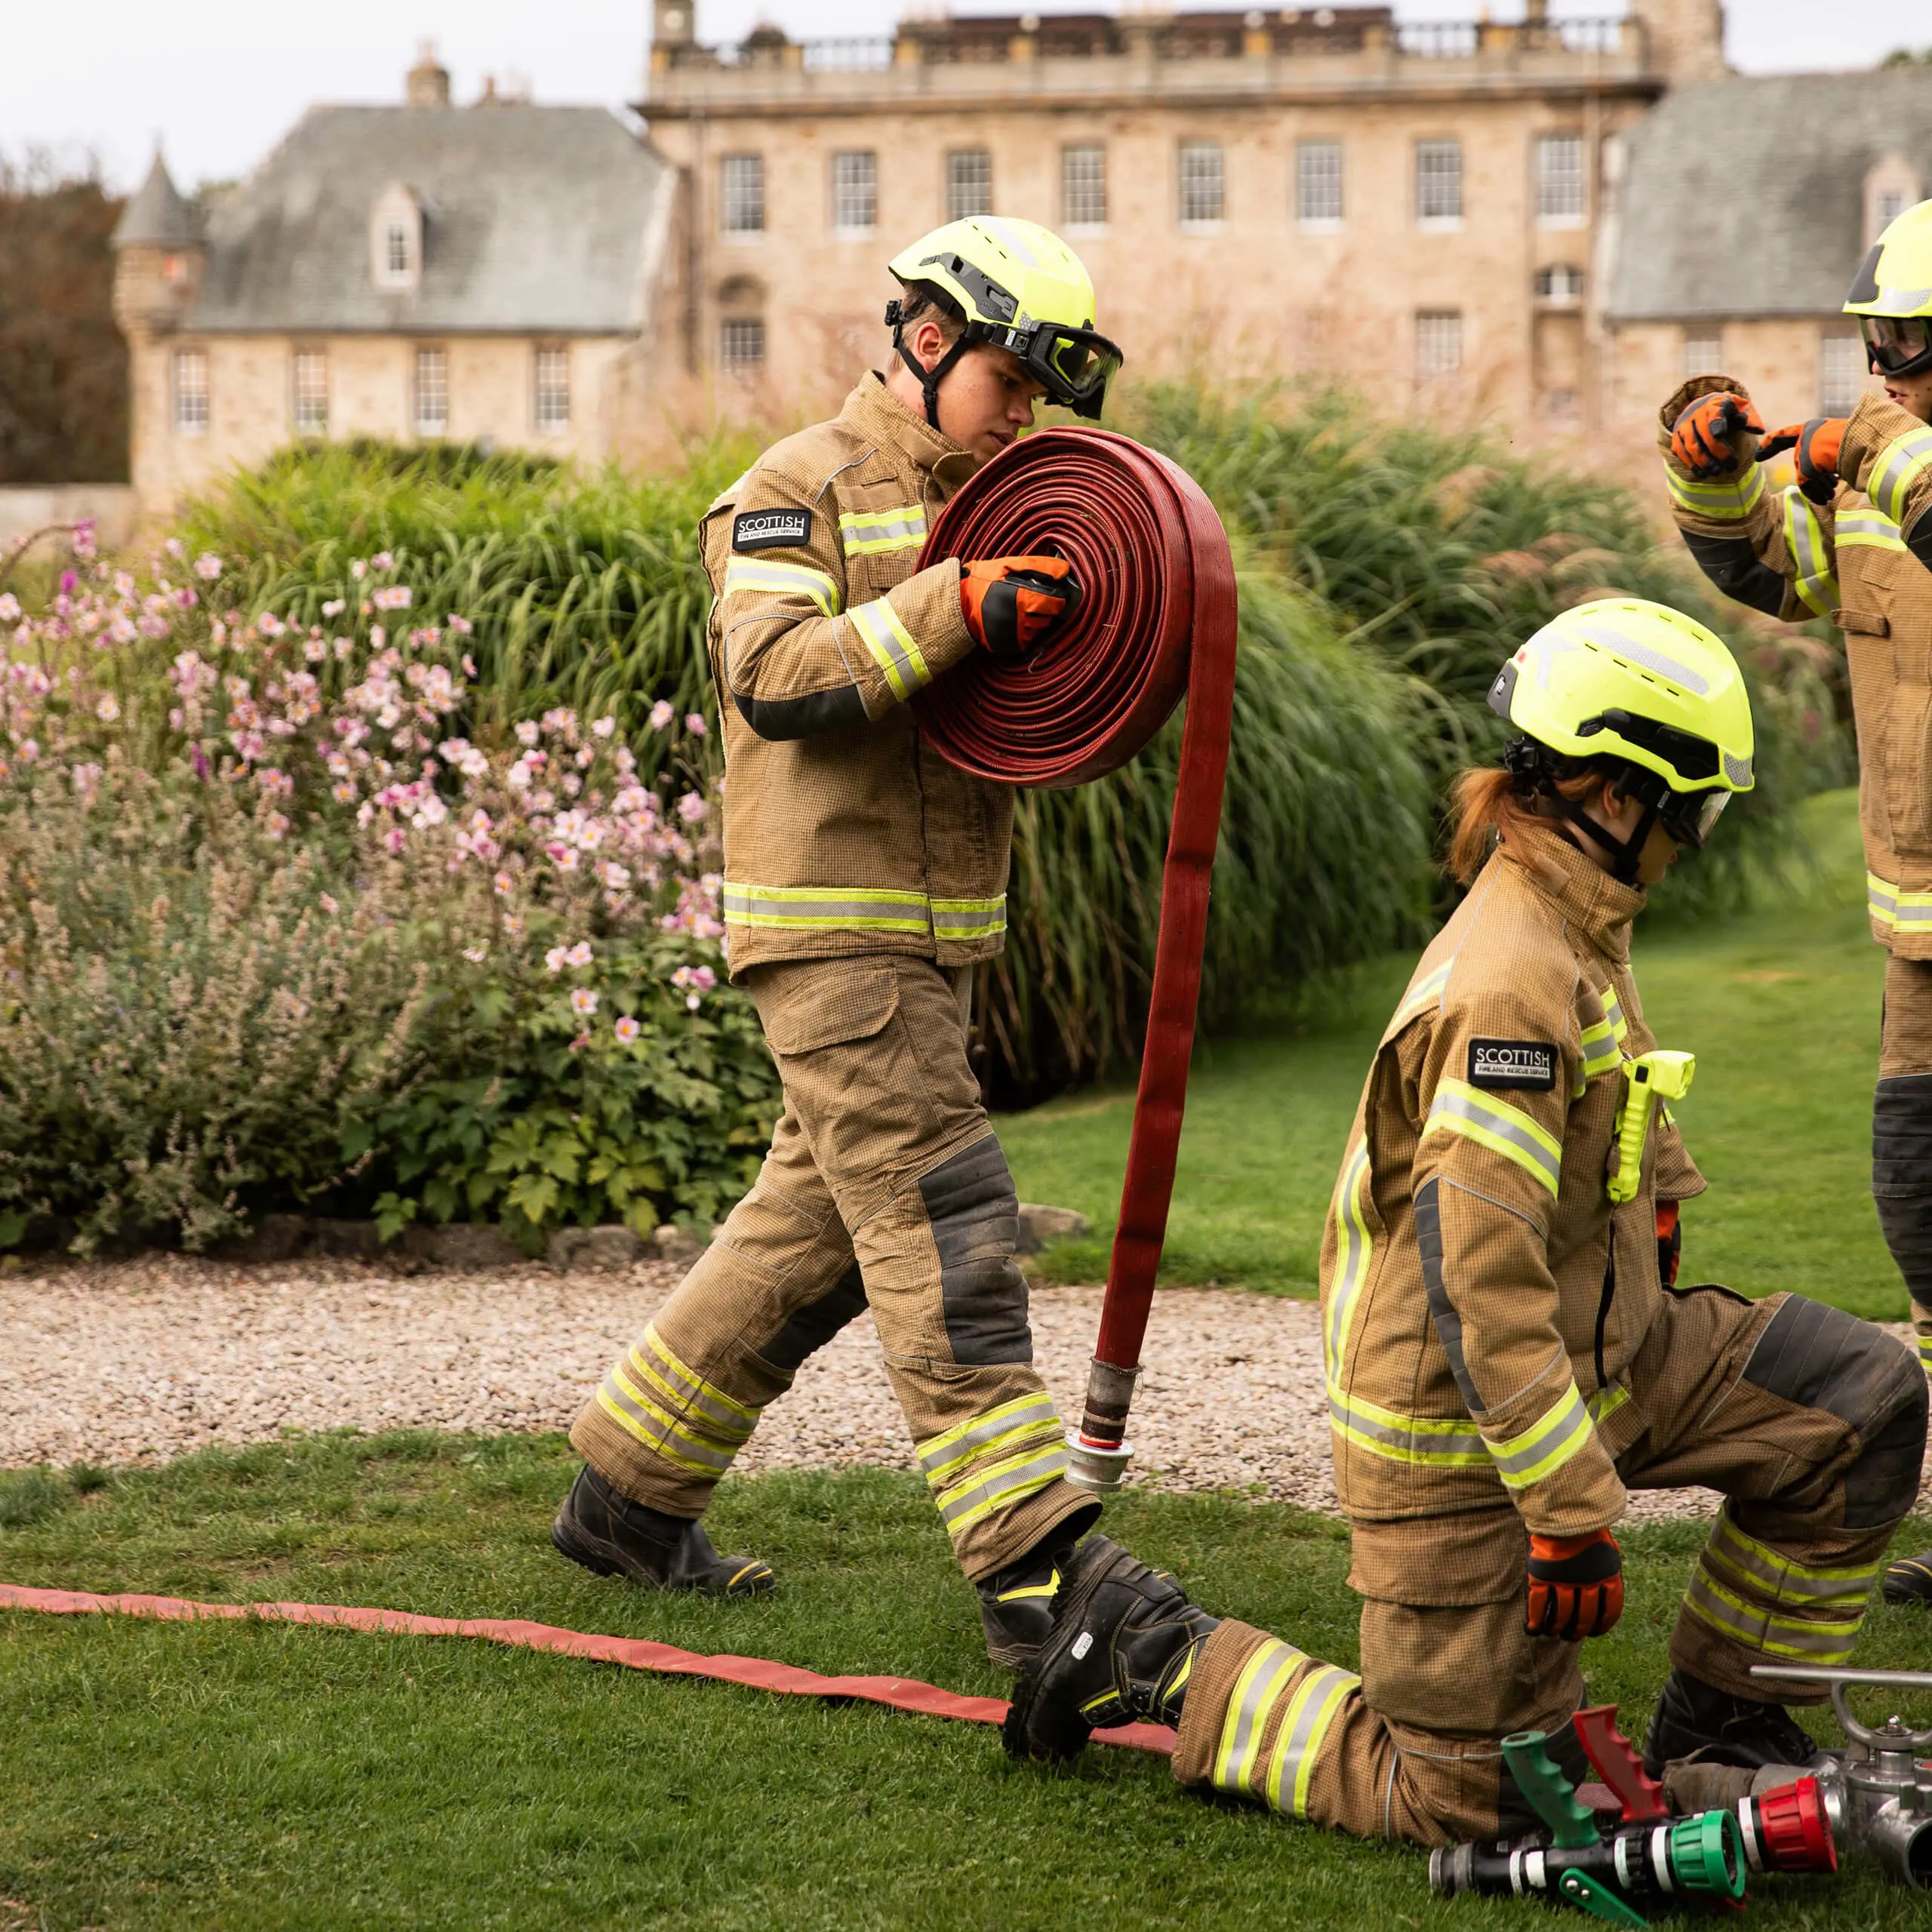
[884,214,1126,429]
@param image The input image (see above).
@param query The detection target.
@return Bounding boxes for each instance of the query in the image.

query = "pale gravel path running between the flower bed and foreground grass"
[0,1256,1903,1517]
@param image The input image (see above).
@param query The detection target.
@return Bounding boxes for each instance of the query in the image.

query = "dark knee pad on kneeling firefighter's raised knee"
[1745,1294,1926,1531]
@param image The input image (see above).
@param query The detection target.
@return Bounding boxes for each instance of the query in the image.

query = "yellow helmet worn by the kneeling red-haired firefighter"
[1490,597,1756,883]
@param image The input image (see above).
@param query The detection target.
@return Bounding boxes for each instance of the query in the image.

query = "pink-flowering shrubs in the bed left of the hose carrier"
[0,537,777,1246]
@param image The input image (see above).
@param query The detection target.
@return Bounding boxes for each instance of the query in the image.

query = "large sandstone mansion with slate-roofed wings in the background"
[116,0,1932,508]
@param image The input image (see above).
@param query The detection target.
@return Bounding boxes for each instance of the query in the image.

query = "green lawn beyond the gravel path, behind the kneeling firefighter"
[999,792,1907,1319]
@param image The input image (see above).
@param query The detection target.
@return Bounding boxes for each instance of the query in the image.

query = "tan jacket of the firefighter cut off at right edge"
[1657,375,1932,960]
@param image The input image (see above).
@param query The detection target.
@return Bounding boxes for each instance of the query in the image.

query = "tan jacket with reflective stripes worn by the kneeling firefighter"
[1321,829,1704,1536]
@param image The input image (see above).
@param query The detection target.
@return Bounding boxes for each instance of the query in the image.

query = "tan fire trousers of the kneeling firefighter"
[1174,1289,1926,1845]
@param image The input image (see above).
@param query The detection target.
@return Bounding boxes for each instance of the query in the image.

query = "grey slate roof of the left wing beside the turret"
[182,103,670,334]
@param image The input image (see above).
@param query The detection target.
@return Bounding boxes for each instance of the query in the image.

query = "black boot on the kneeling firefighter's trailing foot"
[1001,1536,1221,1762]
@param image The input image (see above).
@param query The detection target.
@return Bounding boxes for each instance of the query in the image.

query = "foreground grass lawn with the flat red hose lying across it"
[0,1434,1932,1932]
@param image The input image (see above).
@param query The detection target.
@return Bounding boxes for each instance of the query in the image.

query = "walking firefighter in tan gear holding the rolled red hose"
[552,217,1121,1667]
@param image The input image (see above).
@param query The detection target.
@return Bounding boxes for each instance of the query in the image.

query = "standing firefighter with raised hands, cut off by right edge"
[1657,201,1932,1601]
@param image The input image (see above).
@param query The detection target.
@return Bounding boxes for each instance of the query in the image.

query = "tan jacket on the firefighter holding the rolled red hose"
[700,375,1012,976]
